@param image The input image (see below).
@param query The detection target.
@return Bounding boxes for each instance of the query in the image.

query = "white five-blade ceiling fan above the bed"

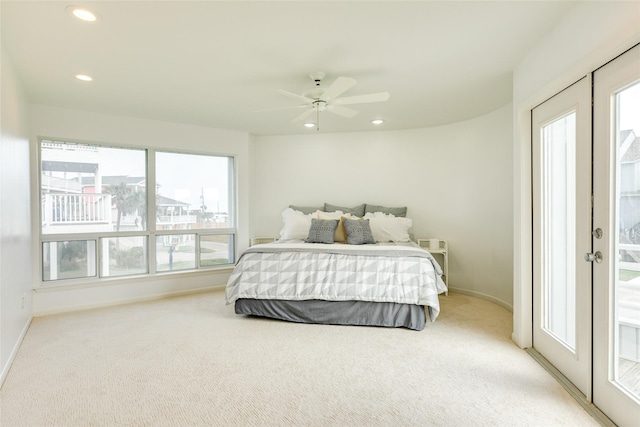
[260,71,389,130]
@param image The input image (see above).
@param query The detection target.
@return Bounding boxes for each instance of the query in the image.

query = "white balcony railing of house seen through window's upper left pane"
[42,194,111,227]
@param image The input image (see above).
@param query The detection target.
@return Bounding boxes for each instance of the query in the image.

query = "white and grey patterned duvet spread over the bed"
[226,243,446,321]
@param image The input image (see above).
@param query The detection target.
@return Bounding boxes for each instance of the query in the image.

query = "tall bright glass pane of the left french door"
[541,112,576,351]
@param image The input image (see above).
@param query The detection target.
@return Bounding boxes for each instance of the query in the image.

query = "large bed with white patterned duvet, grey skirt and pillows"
[226,206,447,331]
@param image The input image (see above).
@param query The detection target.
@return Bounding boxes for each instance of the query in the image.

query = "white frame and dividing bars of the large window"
[35,136,238,288]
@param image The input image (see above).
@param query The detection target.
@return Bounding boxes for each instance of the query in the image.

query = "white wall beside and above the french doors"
[513,1,640,347]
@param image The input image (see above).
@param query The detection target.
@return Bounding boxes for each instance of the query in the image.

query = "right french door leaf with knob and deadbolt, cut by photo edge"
[593,45,640,426]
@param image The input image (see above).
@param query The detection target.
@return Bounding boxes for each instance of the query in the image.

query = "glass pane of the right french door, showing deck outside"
[613,83,640,398]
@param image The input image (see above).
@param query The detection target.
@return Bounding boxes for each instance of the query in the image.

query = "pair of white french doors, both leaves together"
[532,45,640,426]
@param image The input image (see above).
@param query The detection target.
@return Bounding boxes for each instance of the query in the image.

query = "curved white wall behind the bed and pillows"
[251,105,513,307]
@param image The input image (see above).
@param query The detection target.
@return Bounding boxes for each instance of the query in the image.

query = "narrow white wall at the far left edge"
[0,45,31,385]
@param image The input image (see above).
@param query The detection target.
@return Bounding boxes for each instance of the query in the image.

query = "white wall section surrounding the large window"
[30,105,250,315]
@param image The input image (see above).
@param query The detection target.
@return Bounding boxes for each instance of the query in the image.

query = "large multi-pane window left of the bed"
[40,139,236,282]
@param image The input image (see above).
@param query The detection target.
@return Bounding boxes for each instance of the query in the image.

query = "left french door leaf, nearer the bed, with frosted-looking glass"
[532,76,591,398]
